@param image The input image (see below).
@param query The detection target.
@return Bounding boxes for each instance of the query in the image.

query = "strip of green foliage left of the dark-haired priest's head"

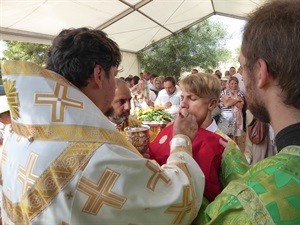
[3,41,50,66]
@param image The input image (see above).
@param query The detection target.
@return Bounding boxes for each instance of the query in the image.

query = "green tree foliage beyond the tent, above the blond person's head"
[138,20,231,77]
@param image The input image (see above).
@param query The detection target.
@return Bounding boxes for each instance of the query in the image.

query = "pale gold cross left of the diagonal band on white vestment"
[18,153,38,193]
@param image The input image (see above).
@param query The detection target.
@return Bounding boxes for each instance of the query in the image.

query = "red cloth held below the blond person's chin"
[149,125,226,201]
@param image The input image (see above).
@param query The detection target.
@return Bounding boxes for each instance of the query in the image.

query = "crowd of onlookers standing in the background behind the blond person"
[120,62,270,160]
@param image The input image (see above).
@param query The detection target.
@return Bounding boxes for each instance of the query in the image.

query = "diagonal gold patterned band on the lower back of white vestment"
[2,143,102,224]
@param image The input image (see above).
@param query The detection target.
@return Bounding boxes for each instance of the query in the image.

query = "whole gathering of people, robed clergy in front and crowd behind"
[0,0,300,225]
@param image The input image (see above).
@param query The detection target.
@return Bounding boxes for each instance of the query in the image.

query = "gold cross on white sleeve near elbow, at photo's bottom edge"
[165,186,192,225]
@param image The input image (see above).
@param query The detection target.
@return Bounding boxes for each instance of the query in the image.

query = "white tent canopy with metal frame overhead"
[0,0,263,74]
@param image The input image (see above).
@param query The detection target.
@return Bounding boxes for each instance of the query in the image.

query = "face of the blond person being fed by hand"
[181,89,211,127]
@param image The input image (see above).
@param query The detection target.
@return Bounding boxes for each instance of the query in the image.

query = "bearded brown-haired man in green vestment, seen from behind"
[199,0,300,225]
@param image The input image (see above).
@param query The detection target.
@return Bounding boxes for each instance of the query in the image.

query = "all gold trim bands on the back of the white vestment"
[2,61,141,224]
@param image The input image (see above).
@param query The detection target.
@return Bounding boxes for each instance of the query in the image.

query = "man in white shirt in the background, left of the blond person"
[154,77,181,118]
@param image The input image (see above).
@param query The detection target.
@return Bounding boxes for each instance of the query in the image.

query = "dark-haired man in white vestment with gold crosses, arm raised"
[0,28,204,225]
